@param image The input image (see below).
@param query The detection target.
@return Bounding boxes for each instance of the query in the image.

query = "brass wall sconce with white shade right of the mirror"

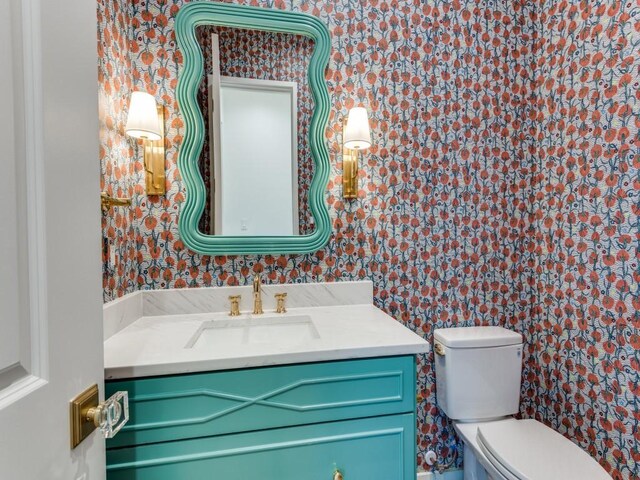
[342,107,371,198]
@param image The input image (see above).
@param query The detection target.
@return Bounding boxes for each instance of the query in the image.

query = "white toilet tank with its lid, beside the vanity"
[434,327,522,422]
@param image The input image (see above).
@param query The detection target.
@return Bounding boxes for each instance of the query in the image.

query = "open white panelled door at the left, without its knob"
[0,0,105,474]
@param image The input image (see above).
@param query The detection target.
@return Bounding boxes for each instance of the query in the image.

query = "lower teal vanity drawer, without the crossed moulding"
[107,414,416,480]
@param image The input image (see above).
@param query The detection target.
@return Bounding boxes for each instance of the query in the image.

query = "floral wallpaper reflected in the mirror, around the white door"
[196,25,314,235]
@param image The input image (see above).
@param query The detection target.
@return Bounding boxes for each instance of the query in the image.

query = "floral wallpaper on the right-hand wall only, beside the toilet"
[522,0,640,479]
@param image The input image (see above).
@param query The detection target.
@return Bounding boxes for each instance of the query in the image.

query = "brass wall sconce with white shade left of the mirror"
[125,92,166,195]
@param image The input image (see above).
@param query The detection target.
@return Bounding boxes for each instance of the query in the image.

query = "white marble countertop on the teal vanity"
[104,282,430,379]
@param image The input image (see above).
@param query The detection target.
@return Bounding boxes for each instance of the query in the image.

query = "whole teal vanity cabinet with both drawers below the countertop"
[106,355,416,480]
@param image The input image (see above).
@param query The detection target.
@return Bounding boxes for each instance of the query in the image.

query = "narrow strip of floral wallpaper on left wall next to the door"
[98,0,144,300]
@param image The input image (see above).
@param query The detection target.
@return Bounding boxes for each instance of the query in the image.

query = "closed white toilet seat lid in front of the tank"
[477,420,611,480]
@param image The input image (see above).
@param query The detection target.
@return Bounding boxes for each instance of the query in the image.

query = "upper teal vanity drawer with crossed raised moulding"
[106,356,415,448]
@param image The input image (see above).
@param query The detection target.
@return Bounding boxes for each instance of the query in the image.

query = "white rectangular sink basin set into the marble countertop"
[184,315,320,348]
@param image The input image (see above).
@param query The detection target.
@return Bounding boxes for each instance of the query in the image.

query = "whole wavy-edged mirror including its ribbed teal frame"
[176,2,330,254]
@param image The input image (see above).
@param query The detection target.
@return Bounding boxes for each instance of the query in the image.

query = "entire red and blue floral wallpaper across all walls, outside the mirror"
[98,0,640,479]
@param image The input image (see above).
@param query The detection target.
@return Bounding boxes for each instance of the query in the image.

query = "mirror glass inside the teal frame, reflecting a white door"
[196,25,314,236]
